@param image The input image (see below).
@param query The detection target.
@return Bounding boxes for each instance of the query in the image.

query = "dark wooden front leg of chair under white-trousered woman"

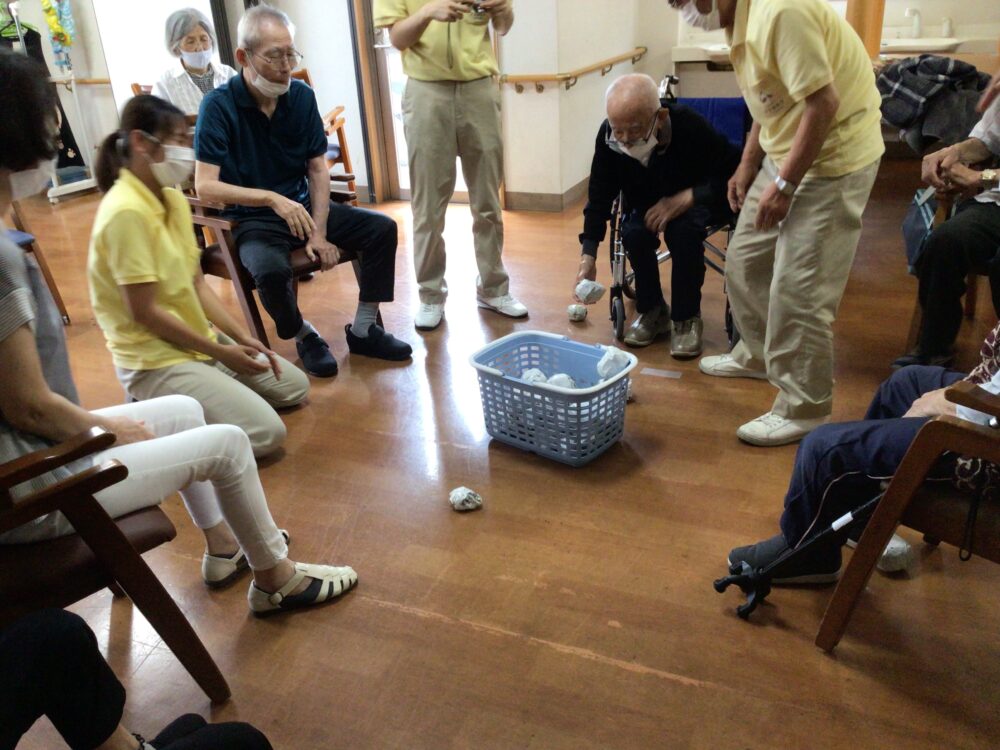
[64,496,232,703]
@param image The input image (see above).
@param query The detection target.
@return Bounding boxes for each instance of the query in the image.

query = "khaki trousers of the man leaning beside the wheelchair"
[726,159,878,419]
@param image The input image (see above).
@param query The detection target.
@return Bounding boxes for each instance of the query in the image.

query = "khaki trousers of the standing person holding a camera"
[403,78,509,304]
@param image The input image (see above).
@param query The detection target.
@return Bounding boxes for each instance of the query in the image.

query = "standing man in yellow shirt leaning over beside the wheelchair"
[670,0,885,446]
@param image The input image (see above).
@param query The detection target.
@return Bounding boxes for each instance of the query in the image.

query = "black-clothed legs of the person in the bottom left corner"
[0,609,271,750]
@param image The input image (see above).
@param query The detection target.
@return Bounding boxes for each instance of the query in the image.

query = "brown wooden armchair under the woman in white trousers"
[0,428,230,703]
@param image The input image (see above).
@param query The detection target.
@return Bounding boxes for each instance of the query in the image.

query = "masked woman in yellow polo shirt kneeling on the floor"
[87,96,309,457]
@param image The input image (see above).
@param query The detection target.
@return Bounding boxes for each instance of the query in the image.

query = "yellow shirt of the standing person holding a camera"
[375,0,499,81]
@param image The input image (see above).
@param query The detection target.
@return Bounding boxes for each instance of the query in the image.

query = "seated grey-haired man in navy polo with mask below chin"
[195,0,412,377]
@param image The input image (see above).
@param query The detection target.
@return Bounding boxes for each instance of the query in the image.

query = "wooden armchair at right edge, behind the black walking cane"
[816,381,1000,651]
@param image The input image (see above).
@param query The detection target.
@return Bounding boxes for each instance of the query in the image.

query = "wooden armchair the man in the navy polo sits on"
[188,192,374,347]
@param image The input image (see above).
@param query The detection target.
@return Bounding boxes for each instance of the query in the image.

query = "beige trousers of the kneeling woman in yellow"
[118,333,309,458]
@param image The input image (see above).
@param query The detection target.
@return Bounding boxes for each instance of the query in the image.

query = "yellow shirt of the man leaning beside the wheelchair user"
[730,0,885,177]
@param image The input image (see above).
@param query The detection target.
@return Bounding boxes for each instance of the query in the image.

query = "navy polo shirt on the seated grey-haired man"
[194,73,327,220]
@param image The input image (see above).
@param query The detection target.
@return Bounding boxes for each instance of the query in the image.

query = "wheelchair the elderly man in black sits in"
[608,75,740,349]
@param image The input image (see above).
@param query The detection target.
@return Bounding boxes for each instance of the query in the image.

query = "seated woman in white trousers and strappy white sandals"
[0,51,358,614]
